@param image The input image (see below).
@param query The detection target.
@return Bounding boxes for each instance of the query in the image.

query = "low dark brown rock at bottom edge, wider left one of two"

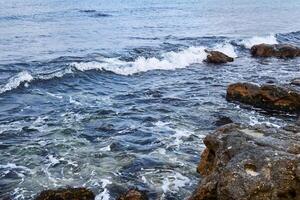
[35,188,95,200]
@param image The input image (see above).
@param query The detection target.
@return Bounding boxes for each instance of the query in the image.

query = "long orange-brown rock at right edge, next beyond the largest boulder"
[226,83,300,113]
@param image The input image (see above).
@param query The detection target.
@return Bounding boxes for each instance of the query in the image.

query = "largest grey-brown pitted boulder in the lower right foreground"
[189,124,300,200]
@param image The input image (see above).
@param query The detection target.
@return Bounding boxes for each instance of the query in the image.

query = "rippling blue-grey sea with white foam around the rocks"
[0,0,300,200]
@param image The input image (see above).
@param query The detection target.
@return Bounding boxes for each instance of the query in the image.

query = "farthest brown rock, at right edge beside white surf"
[251,44,300,58]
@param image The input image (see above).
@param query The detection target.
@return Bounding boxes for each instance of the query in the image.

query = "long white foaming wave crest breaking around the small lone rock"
[0,43,237,94]
